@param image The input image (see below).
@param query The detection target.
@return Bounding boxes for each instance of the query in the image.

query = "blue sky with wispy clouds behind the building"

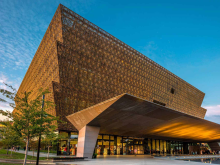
[0,0,220,123]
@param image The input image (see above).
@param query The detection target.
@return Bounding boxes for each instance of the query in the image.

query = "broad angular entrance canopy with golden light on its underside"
[67,94,220,142]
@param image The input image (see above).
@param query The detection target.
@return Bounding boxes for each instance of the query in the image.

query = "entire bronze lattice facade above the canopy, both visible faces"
[18,5,206,131]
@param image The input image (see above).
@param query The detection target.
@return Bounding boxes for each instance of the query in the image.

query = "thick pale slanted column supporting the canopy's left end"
[76,126,100,159]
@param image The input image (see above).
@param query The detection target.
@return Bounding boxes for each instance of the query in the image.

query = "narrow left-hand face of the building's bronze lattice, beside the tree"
[18,6,63,120]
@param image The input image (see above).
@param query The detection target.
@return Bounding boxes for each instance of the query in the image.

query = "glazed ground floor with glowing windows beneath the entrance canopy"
[57,131,205,155]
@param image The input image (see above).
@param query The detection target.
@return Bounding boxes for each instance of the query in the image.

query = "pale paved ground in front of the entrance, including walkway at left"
[6,153,220,165]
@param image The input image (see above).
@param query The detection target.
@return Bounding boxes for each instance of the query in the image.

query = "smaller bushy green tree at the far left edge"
[0,121,22,156]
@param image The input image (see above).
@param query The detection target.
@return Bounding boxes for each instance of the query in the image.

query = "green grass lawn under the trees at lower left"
[0,149,47,160]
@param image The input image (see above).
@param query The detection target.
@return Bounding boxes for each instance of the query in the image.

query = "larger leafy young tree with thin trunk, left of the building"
[0,84,58,165]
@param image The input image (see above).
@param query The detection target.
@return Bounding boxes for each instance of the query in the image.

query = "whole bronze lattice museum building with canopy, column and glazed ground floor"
[18,4,220,158]
